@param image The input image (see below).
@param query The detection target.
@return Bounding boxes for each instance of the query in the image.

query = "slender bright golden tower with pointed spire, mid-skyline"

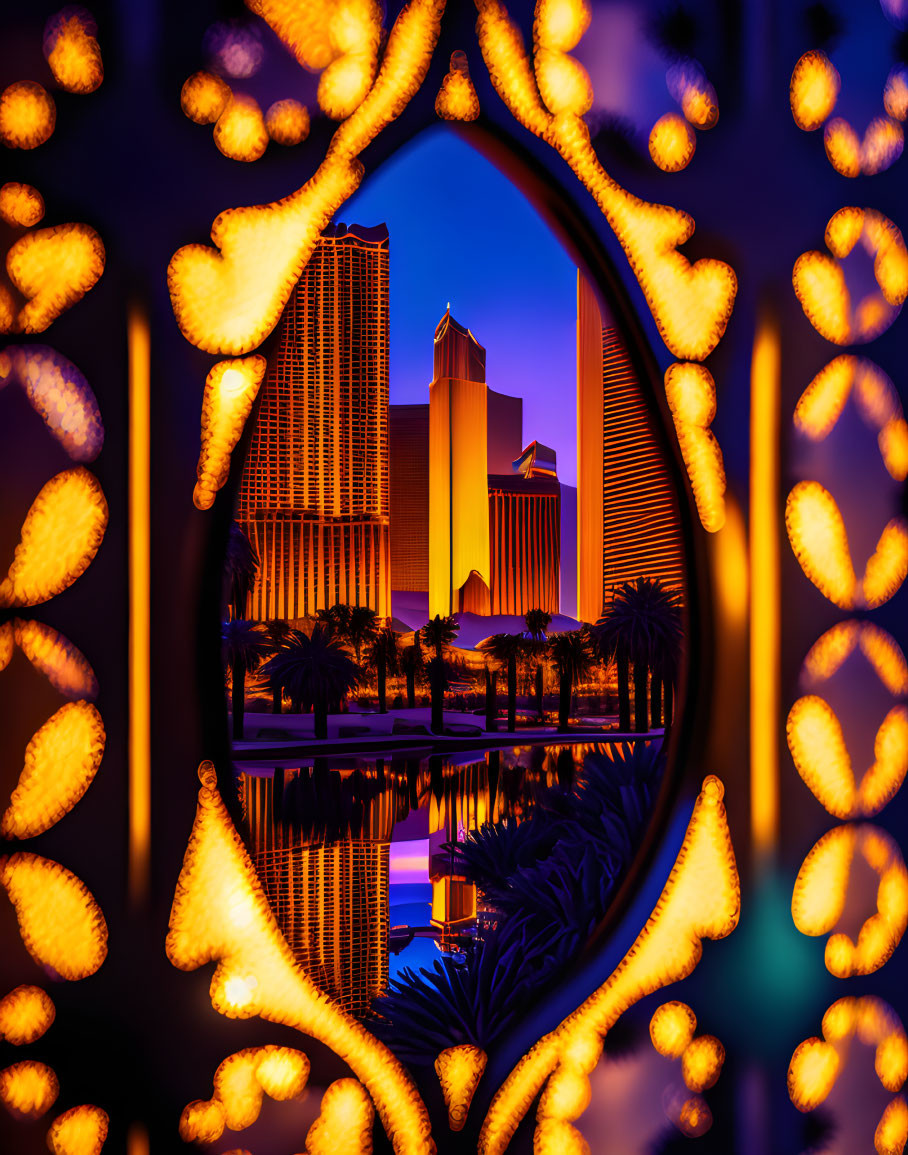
[429,312,491,617]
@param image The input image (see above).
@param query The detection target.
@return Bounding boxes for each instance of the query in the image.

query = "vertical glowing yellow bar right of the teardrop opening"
[750,312,781,862]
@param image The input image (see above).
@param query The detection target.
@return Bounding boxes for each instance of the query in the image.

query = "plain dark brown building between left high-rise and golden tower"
[388,405,429,593]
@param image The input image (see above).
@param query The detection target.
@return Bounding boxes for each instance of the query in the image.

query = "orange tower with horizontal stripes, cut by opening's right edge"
[578,273,684,621]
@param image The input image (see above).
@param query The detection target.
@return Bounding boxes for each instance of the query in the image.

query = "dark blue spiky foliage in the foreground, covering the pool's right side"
[371,743,664,1066]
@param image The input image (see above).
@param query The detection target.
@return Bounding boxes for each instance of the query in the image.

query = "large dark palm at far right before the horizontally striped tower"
[594,578,682,732]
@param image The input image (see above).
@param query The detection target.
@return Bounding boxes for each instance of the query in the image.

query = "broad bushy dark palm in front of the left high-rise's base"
[256,624,362,738]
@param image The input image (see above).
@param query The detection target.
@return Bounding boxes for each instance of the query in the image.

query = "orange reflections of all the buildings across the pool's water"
[243,745,610,1002]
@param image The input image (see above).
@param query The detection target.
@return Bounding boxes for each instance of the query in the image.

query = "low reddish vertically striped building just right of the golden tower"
[489,474,561,614]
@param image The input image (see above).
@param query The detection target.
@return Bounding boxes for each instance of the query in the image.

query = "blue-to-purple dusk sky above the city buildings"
[338,127,576,485]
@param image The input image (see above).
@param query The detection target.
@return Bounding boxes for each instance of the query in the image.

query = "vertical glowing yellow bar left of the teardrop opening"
[128,304,151,908]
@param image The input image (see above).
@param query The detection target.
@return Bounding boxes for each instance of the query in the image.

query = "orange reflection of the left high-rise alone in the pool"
[244,772,394,1016]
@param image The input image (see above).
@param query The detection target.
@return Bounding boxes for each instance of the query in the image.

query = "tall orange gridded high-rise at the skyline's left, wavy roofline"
[237,224,390,620]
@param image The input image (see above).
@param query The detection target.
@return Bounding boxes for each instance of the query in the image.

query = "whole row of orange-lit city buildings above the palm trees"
[229,223,683,627]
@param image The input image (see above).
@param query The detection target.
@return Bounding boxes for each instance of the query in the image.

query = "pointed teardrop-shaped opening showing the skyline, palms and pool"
[217,129,689,1066]
